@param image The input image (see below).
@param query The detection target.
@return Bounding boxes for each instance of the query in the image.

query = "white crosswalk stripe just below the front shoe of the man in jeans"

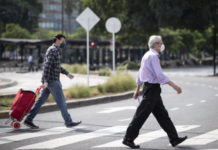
[0,126,85,144]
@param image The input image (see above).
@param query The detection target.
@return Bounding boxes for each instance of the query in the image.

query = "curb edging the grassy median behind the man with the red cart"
[0,92,134,119]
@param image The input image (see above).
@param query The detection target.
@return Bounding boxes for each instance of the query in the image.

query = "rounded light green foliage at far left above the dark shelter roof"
[2,23,31,39]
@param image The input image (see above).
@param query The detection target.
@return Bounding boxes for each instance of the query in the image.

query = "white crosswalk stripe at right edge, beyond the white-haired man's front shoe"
[181,129,218,145]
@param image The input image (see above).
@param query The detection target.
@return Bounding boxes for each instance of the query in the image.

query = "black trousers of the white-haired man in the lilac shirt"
[125,83,178,141]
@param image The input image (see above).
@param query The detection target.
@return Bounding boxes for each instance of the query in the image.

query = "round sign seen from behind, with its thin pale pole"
[105,17,121,72]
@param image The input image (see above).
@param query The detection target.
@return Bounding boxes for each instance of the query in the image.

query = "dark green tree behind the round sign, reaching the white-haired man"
[83,0,158,46]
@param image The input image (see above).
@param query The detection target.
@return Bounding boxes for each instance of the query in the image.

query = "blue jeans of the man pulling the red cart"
[26,81,72,125]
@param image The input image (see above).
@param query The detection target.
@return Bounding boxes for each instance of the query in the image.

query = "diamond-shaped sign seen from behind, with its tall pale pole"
[76,7,100,85]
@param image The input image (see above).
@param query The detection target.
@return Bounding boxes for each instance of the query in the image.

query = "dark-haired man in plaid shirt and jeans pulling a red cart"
[24,34,81,129]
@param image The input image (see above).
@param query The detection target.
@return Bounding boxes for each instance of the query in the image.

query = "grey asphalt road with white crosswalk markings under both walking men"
[0,74,218,150]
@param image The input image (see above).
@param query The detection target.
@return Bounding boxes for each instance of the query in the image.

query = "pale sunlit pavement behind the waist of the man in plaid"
[0,71,108,95]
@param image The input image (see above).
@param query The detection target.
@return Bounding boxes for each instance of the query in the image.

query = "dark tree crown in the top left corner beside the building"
[0,0,42,33]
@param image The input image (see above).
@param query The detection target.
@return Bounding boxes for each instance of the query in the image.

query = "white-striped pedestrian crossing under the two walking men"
[0,125,218,150]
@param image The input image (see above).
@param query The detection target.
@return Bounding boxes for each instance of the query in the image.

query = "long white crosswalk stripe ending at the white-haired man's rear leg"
[17,126,126,149]
